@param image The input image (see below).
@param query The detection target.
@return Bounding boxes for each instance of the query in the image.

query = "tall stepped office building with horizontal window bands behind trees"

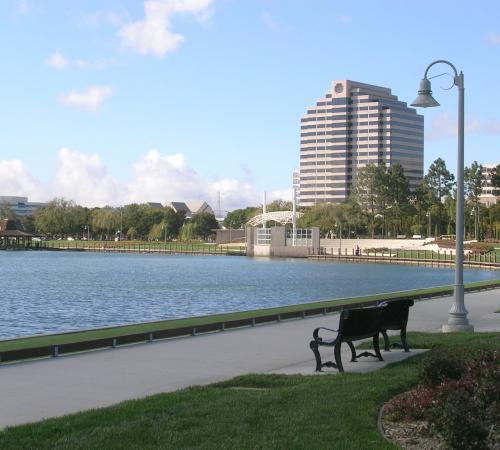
[300,80,424,206]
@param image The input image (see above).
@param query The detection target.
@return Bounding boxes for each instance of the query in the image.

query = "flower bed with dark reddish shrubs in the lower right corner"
[383,347,500,450]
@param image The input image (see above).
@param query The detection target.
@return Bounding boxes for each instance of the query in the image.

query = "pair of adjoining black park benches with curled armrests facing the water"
[309,299,413,372]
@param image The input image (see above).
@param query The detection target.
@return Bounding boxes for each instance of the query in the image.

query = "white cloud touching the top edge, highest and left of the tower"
[119,0,212,57]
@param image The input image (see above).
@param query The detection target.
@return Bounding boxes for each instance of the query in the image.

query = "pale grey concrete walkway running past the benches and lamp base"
[0,290,500,428]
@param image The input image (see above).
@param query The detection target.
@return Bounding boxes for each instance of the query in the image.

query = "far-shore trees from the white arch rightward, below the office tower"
[224,158,500,240]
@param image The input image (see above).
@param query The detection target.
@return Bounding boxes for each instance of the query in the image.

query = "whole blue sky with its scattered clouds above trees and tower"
[0,0,500,209]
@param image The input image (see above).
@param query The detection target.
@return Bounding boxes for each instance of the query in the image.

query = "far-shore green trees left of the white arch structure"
[0,198,219,240]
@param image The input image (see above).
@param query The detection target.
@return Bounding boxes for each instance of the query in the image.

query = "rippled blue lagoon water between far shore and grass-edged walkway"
[0,251,499,339]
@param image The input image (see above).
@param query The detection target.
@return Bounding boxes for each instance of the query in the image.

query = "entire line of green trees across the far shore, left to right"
[0,158,500,240]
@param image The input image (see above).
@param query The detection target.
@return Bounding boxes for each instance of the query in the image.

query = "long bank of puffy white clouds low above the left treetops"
[0,148,291,211]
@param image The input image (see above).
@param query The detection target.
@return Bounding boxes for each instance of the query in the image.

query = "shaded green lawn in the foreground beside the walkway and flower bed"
[0,333,500,450]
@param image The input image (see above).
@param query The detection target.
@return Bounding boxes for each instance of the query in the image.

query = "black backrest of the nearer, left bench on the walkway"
[339,307,383,341]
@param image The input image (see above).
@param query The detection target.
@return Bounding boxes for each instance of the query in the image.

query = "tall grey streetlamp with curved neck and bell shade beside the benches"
[411,59,474,333]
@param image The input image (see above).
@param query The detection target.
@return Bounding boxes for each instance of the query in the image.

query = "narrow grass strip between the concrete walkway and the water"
[0,280,500,352]
